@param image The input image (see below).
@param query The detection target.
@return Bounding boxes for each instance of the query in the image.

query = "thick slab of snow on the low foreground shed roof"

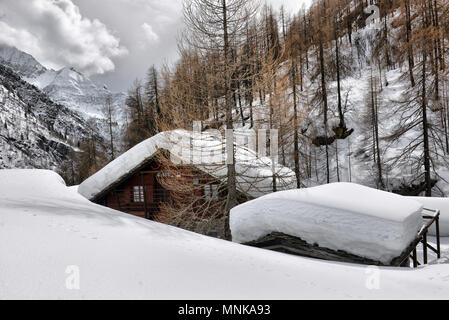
[231,183,422,263]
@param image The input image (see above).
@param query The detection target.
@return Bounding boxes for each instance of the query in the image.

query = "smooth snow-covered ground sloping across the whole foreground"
[0,170,449,299]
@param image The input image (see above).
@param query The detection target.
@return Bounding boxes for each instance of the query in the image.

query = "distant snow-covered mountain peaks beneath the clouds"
[0,45,126,119]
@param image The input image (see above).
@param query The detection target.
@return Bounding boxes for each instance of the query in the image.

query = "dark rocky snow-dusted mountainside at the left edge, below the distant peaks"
[0,62,88,169]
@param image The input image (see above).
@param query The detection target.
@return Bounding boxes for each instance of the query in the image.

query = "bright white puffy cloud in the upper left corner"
[0,0,128,74]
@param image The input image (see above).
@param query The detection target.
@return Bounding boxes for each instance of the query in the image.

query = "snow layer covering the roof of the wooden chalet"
[78,130,296,199]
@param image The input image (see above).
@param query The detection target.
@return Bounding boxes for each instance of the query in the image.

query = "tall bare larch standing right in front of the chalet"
[184,0,256,240]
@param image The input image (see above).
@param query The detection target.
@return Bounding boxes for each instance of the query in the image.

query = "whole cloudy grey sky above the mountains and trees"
[0,0,312,91]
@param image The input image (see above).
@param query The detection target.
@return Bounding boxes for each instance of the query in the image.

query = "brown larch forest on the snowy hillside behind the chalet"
[60,0,449,200]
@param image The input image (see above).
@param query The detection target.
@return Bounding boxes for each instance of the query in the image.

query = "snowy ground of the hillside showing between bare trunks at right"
[226,12,449,197]
